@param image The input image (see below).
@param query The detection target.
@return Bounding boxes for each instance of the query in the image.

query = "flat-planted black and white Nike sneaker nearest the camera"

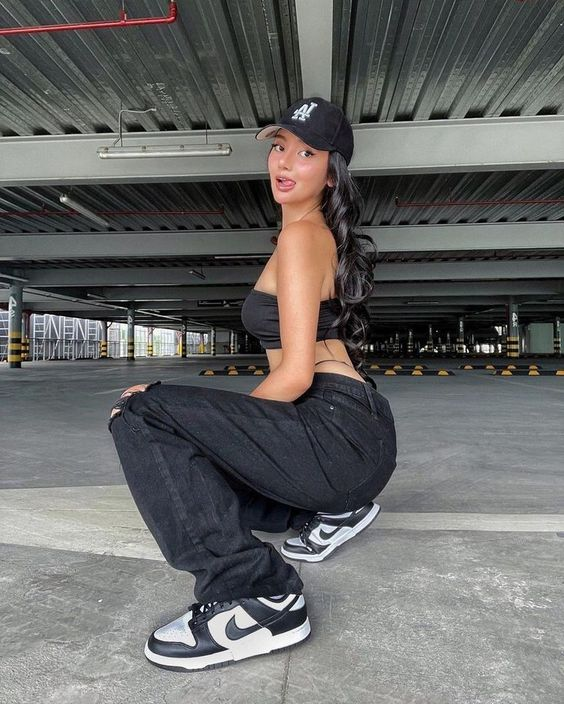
[145,594,311,671]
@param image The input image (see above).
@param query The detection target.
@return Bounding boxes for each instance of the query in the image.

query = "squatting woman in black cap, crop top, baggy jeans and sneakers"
[110,97,396,670]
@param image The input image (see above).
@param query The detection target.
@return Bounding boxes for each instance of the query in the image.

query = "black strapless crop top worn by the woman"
[241,288,340,349]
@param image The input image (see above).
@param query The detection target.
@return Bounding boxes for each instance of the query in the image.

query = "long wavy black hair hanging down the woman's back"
[321,151,378,386]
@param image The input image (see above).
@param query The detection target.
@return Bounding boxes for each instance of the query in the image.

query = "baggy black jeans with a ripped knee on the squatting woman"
[110,372,396,603]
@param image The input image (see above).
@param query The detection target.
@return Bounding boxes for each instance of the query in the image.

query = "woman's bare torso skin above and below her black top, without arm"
[254,231,366,384]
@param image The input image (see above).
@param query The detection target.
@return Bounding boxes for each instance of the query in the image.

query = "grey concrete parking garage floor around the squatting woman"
[0,356,564,704]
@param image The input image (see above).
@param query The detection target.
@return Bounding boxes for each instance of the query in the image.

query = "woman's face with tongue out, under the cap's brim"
[268,127,330,204]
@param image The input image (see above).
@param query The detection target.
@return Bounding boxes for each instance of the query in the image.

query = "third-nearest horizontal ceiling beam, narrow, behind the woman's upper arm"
[12,259,564,290]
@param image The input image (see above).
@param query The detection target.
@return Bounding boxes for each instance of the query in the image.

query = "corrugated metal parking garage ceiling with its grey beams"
[0,0,564,333]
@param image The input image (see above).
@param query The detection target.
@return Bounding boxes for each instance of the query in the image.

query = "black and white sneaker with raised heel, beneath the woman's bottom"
[281,501,380,562]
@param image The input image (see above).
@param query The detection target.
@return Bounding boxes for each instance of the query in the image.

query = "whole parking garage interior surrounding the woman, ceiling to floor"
[0,0,564,704]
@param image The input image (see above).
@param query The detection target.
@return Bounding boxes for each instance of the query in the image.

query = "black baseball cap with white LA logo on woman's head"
[255,97,354,164]
